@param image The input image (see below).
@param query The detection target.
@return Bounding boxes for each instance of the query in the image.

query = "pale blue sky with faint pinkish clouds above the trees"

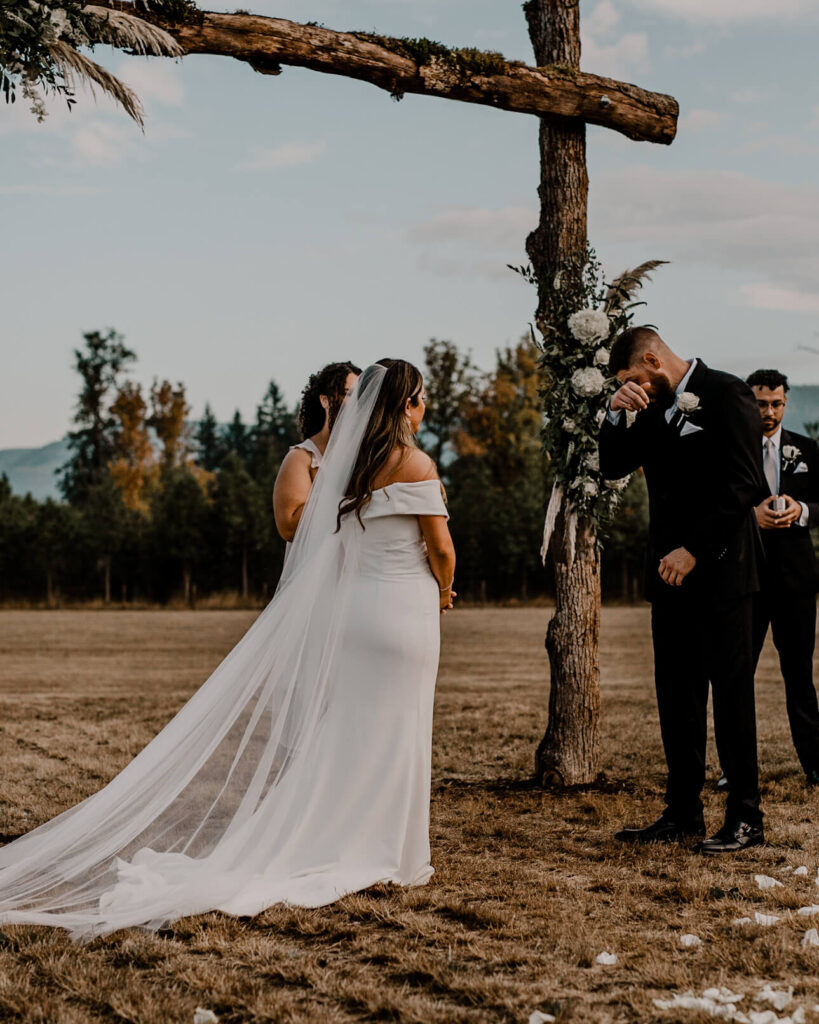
[0,0,819,447]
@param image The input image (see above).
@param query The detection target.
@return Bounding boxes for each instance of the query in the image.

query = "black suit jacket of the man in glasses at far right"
[761,428,819,594]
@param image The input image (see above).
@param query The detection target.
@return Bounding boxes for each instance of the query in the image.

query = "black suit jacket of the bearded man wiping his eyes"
[600,361,769,601]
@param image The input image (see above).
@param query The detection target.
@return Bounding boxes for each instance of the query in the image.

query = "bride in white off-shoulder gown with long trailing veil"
[0,359,455,938]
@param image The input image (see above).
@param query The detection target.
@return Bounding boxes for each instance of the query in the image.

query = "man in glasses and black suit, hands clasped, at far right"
[745,370,819,787]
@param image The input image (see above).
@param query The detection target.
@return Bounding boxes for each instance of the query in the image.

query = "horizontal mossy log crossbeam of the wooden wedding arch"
[95,0,679,144]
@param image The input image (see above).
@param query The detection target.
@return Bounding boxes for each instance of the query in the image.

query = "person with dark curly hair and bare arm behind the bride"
[273,361,361,542]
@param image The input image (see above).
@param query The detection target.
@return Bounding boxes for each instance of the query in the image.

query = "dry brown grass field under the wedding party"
[0,607,819,1024]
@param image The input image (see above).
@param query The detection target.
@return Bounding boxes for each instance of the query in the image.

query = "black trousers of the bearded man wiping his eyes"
[651,587,762,824]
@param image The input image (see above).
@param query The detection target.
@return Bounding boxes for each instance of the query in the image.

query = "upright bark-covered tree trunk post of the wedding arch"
[524,0,600,786]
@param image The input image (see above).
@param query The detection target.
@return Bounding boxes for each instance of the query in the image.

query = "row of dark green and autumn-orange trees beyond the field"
[0,331,646,606]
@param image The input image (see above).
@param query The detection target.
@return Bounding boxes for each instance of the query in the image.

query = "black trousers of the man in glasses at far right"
[753,587,819,777]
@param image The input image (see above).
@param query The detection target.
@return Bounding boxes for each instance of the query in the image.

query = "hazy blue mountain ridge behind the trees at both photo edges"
[0,384,819,501]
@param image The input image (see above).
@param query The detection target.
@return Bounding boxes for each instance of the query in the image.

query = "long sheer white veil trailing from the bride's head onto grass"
[0,366,385,938]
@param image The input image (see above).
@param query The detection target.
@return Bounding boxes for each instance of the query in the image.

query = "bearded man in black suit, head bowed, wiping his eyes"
[600,327,769,854]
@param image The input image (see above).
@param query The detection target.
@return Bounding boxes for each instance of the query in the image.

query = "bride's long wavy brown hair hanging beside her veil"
[338,359,424,524]
